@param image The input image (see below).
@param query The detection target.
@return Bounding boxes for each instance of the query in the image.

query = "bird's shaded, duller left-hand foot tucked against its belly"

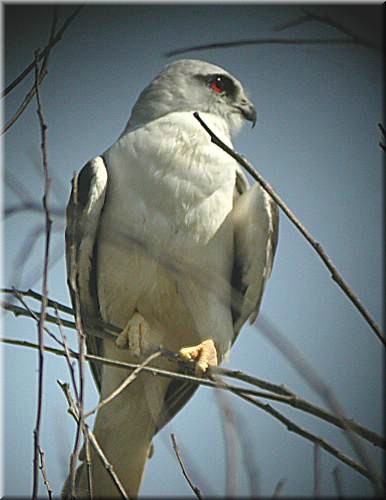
[115,312,150,357]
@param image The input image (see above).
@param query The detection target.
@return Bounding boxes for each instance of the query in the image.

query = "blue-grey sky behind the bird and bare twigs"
[3,4,383,496]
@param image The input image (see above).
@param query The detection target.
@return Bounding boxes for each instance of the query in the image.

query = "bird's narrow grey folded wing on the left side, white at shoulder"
[66,156,108,389]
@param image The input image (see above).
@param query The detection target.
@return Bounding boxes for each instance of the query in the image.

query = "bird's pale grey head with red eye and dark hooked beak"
[129,59,256,132]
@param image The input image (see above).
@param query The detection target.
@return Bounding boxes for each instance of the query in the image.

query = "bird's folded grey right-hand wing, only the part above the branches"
[232,174,279,336]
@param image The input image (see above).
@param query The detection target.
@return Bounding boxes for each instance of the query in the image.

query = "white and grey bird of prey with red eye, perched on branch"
[63,59,278,497]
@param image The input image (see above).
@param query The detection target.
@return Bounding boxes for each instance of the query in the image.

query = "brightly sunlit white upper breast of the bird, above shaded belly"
[107,115,235,244]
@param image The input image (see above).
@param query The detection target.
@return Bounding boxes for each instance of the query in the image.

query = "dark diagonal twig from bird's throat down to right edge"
[193,112,386,345]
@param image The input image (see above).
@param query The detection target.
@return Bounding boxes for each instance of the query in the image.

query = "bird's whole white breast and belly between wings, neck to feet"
[98,112,235,358]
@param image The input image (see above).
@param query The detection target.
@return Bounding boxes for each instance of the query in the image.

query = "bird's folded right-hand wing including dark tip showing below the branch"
[158,170,278,431]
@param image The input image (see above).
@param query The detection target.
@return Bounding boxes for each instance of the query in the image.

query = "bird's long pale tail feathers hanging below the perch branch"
[62,370,168,499]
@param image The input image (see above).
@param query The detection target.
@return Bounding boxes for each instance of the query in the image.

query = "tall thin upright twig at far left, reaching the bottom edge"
[32,51,52,499]
